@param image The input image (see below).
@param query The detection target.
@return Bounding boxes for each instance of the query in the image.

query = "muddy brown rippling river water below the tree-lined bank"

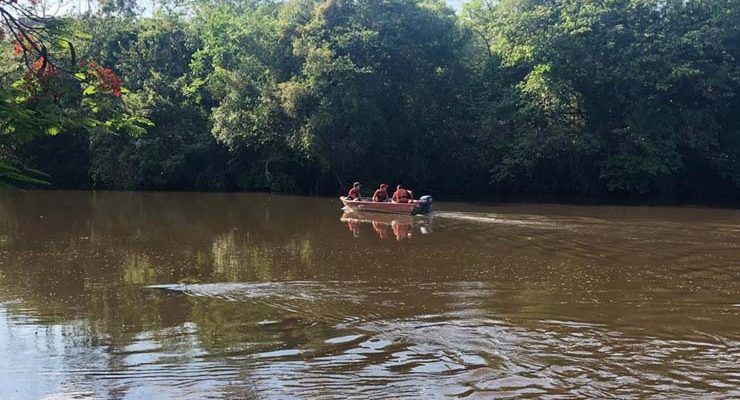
[0,191,740,399]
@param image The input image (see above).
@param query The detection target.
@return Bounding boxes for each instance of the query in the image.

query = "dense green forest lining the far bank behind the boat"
[0,0,740,201]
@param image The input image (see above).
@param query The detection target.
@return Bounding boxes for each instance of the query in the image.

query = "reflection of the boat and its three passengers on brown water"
[340,211,432,241]
